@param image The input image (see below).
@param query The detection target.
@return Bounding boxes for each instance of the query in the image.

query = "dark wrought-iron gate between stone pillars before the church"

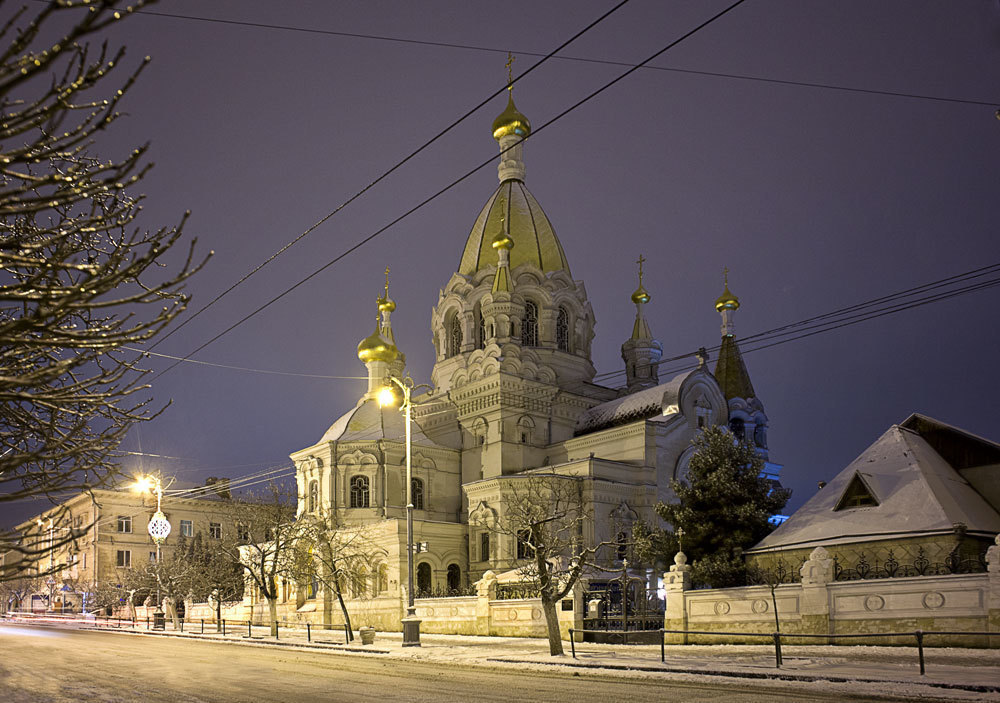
[583,569,665,644]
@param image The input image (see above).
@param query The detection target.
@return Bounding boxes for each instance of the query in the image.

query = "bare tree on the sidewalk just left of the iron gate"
[494,474,611,656]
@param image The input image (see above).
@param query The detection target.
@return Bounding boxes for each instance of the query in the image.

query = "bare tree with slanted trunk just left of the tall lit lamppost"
[290,509,386,639]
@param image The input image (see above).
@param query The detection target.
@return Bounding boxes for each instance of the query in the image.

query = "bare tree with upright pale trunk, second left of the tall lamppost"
[220,483,299,635]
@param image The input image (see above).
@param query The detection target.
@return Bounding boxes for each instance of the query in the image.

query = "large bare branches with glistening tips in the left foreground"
[0,0,204,579]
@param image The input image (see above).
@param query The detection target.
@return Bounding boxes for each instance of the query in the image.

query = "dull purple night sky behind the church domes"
[2,0,1000,524]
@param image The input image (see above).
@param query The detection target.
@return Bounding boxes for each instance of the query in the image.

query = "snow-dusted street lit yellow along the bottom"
[0,626,960,703]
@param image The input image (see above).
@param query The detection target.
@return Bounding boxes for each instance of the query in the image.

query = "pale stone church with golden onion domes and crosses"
[291,86,780,596]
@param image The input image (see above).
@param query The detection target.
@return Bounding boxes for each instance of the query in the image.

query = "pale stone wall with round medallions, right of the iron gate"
[664,536,1000,647]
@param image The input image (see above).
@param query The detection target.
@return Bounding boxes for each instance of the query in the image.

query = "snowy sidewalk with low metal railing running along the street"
[80,624,1000,700]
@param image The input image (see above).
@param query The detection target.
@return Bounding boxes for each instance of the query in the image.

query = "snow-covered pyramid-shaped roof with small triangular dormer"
[749,418,1000,553]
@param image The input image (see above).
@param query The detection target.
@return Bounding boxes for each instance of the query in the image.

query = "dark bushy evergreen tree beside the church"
[645,427,791,588]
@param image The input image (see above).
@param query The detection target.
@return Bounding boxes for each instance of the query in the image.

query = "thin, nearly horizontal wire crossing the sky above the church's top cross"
[127,0,997,107]
